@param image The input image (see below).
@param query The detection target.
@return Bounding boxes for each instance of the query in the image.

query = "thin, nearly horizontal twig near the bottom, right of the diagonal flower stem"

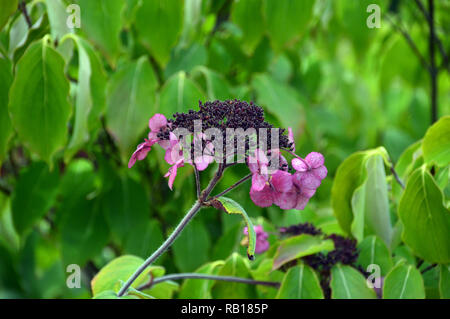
[138,273,280,290]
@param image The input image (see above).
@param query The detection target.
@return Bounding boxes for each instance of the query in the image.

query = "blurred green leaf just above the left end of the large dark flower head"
[159,71,205,116]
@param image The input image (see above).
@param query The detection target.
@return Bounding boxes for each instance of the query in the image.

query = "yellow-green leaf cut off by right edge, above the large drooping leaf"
[422,115,450,166]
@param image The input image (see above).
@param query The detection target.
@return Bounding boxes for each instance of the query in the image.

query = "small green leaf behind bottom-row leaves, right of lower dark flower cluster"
[358,235,393,276]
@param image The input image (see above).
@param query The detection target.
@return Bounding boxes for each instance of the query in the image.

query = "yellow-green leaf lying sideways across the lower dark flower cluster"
[273,234,334,270]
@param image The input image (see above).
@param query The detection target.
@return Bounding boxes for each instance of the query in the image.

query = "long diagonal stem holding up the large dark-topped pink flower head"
[117,201,201,297]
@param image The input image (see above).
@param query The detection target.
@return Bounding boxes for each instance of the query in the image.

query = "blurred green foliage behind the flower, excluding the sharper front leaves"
[0,0,450,298]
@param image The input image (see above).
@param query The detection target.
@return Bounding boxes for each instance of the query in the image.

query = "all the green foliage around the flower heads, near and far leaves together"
[0,0,450,298]
